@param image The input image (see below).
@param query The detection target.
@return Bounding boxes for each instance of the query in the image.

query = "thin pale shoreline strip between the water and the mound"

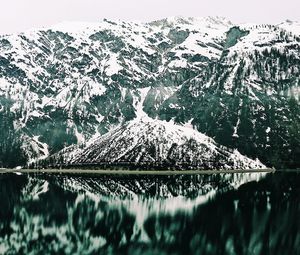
[0,168,276,175]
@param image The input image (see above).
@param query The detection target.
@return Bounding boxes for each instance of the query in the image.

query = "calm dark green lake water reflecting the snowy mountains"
[0,172,300,255]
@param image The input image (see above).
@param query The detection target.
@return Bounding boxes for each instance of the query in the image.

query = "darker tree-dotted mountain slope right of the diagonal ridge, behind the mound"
[158,22,300,168]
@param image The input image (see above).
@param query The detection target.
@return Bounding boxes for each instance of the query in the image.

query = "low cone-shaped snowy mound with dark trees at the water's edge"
[52,117,265,169]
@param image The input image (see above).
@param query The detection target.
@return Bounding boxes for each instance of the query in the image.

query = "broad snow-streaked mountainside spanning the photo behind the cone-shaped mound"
[0,17,300,167]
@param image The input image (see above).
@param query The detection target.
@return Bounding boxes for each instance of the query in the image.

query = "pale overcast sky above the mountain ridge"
[0,0,300,34]
